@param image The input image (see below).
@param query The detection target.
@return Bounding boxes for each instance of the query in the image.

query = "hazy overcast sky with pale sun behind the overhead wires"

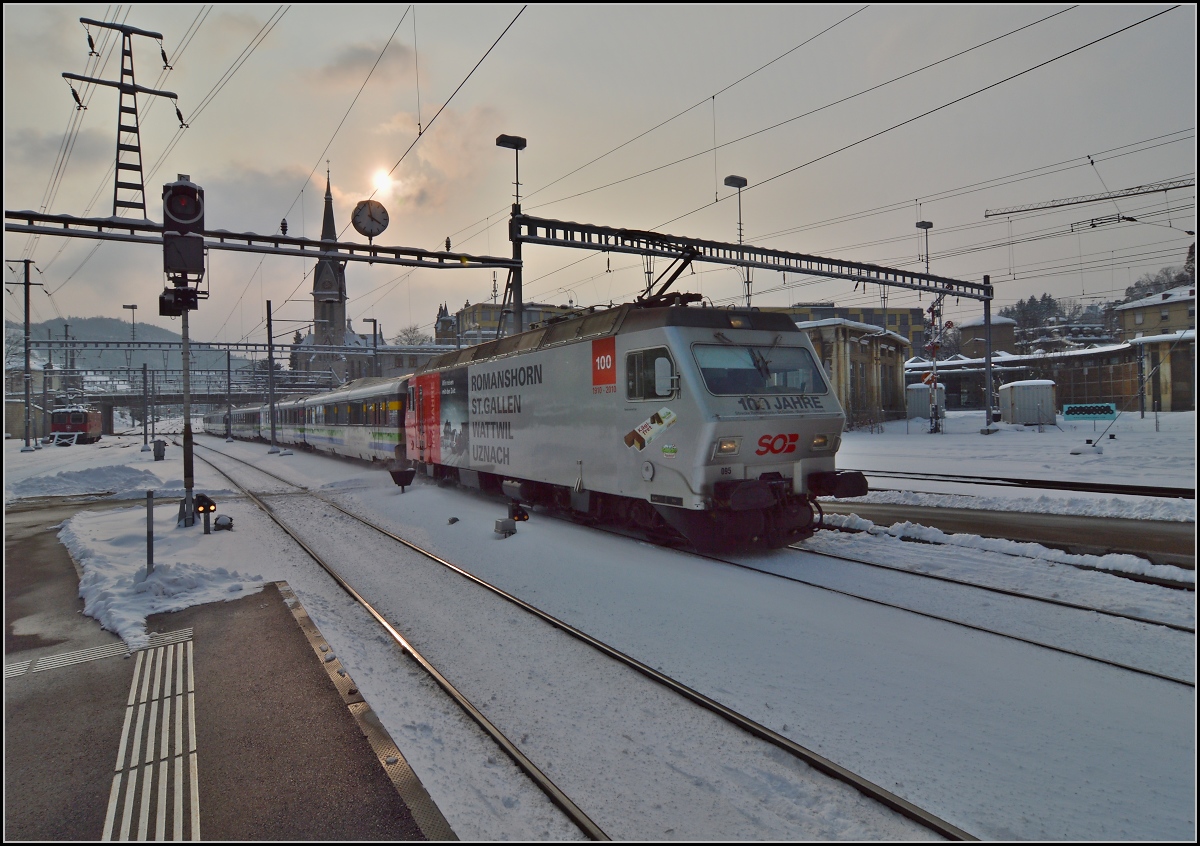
[4,4,1196,341]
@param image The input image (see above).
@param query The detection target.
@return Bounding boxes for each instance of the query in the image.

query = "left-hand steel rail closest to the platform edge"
[186,446,611,840]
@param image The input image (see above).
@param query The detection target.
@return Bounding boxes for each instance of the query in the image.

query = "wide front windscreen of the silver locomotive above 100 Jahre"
[692,344,828,396]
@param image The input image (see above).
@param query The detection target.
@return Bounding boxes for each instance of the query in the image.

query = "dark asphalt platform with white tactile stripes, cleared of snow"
[4,506,456,841]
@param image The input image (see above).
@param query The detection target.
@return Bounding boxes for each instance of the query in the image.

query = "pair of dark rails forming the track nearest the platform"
[187,446,974,840]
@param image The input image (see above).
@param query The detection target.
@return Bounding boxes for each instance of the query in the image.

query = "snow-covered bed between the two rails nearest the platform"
[189,441,973,839]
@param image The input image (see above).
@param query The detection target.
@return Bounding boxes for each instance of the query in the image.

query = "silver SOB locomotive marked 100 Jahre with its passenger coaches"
[206,294,866,550]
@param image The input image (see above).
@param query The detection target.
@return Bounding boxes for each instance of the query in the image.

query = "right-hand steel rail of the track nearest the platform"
[187,446,978,841]
